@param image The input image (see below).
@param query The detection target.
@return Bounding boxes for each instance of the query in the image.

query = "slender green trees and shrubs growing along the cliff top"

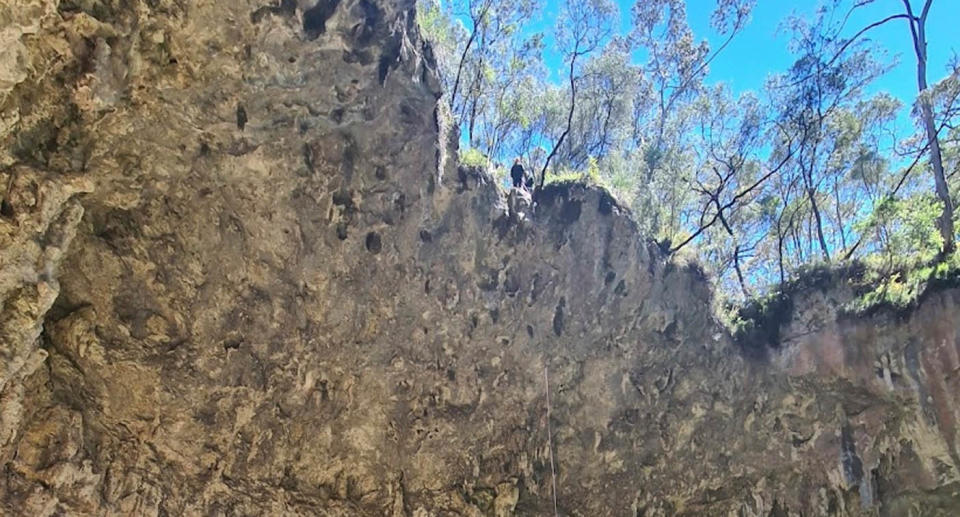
[419,0,960,310]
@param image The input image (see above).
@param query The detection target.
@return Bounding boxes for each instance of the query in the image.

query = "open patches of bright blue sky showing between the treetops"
[530,0,960,111]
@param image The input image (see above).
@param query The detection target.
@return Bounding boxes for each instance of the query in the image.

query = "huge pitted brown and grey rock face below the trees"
[0,0,960,517]
